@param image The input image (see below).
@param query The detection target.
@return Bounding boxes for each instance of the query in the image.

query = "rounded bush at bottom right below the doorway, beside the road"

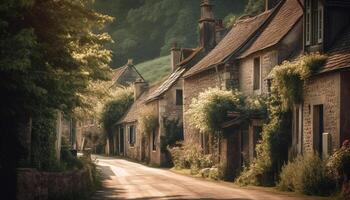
[278,154,335,195]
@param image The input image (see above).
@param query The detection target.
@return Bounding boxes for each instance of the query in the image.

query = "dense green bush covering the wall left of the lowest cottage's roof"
[101,88,133,137]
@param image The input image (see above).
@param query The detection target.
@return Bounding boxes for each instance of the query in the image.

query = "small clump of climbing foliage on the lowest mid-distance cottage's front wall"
[140,108,159,134]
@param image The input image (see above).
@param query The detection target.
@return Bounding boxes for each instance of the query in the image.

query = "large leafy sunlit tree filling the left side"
[0,0,112,199]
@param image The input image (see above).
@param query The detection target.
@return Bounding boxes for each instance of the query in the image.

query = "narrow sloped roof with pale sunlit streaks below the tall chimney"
[146,48,203,102]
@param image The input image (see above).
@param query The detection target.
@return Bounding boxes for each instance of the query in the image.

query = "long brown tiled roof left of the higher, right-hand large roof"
[184,11,271,77]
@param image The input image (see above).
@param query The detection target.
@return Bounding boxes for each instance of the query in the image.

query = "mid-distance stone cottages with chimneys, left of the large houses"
[115,1,226,166]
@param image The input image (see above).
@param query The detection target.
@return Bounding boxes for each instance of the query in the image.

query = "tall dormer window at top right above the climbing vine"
[305,0,324,46]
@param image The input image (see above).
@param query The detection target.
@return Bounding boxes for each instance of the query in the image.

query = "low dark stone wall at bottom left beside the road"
[17,168,93,200]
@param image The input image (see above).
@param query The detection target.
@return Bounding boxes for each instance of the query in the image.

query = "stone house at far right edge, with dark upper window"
[292,0,350,158]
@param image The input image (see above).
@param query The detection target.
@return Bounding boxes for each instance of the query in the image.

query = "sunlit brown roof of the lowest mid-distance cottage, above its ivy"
[118,84,159,124]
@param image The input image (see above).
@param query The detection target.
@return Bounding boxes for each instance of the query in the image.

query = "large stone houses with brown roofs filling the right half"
[183,0,350,179]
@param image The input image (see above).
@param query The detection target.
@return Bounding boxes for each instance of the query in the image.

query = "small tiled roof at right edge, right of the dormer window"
[320,26,350,73]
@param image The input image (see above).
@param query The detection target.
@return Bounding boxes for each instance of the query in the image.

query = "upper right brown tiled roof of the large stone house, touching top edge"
[239,0,303,58]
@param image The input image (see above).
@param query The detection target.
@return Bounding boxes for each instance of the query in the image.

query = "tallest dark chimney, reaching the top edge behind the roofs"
[199,0,216,52]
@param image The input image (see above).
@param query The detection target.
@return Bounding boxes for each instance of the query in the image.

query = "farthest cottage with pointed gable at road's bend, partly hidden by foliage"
[75,60,144,154]
